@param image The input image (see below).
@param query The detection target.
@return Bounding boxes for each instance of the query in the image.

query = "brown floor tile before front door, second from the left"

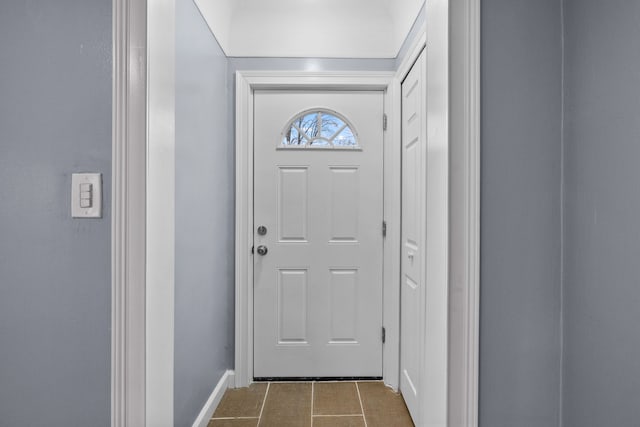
[260,383,311,427]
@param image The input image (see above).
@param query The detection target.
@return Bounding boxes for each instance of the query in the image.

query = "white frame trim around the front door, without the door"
[235,71,400,388]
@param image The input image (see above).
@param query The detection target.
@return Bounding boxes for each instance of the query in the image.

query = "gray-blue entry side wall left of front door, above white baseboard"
[174,0,235,427]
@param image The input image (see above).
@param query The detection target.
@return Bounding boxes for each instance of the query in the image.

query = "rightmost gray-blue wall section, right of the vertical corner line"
[563,0,640,427]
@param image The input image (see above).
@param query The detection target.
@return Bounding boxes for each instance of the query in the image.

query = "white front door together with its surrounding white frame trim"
[235,72,400,389]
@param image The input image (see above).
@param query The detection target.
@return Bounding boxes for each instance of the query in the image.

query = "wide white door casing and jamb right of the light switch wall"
[111,0,175,427]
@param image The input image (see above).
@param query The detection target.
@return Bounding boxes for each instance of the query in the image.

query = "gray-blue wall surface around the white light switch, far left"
[0,0,112,427]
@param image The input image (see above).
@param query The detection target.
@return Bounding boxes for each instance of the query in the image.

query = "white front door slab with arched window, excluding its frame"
[253,91,383,378]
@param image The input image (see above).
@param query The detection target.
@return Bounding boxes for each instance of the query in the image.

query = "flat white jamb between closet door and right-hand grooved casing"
[420,0,451,427]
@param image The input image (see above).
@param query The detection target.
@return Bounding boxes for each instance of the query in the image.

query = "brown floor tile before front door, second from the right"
[313,382,362,415]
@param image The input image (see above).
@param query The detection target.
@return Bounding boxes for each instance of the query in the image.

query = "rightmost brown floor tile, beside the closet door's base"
[358,382,413,427]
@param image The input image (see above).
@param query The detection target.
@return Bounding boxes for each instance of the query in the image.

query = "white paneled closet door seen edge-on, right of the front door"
[400,51,427,425]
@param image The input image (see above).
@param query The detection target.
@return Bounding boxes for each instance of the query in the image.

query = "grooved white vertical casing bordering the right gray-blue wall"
[448,0,480,427]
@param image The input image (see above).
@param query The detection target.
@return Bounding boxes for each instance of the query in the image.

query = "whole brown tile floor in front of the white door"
[208,381,413,427]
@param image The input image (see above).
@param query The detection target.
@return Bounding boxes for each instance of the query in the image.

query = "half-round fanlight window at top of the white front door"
[280,109,360,149]
